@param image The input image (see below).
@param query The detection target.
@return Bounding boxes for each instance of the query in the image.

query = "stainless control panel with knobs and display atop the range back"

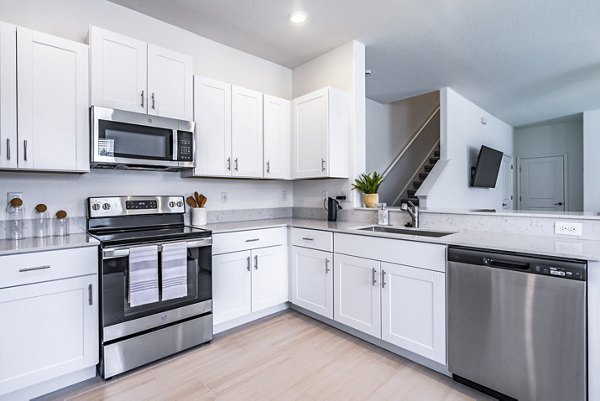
[88,196,185,218]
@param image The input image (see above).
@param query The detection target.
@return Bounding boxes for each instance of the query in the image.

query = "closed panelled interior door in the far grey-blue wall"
[519,155,566,211]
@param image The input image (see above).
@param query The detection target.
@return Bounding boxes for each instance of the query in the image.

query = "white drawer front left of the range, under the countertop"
[0,247,98,288]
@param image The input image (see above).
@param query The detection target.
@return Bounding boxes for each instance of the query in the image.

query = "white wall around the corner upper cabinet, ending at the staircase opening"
[292,41,366,207]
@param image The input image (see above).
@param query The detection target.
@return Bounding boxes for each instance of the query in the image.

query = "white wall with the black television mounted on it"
[427,88,513,210]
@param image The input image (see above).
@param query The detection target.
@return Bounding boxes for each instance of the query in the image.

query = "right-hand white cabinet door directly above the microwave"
[148,45,193,121]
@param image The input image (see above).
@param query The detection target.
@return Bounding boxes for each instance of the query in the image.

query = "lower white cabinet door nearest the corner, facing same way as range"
[252,245,288,312]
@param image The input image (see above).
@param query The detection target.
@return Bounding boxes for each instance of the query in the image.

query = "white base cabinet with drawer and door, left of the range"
[0,247,99,399]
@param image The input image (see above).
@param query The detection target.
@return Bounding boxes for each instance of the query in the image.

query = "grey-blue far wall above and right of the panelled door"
[513,118,583,212]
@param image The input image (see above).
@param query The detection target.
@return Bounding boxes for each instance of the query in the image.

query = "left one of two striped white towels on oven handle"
[129,245,158,307]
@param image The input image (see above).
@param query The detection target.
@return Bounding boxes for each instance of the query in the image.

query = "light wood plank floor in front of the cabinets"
[43,311,491,401]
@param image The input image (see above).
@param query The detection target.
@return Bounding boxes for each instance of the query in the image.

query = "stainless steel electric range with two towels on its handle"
[87,196,212,378]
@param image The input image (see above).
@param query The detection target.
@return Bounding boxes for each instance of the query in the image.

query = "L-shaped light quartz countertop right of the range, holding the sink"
[206,218,600,261]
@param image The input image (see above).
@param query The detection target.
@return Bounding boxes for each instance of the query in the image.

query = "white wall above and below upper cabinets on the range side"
[0,0,293,220]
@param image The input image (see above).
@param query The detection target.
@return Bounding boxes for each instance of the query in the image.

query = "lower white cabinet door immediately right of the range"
[212,251,252,325]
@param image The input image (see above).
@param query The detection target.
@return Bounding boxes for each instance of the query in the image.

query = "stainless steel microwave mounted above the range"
[90,106,195,171]
